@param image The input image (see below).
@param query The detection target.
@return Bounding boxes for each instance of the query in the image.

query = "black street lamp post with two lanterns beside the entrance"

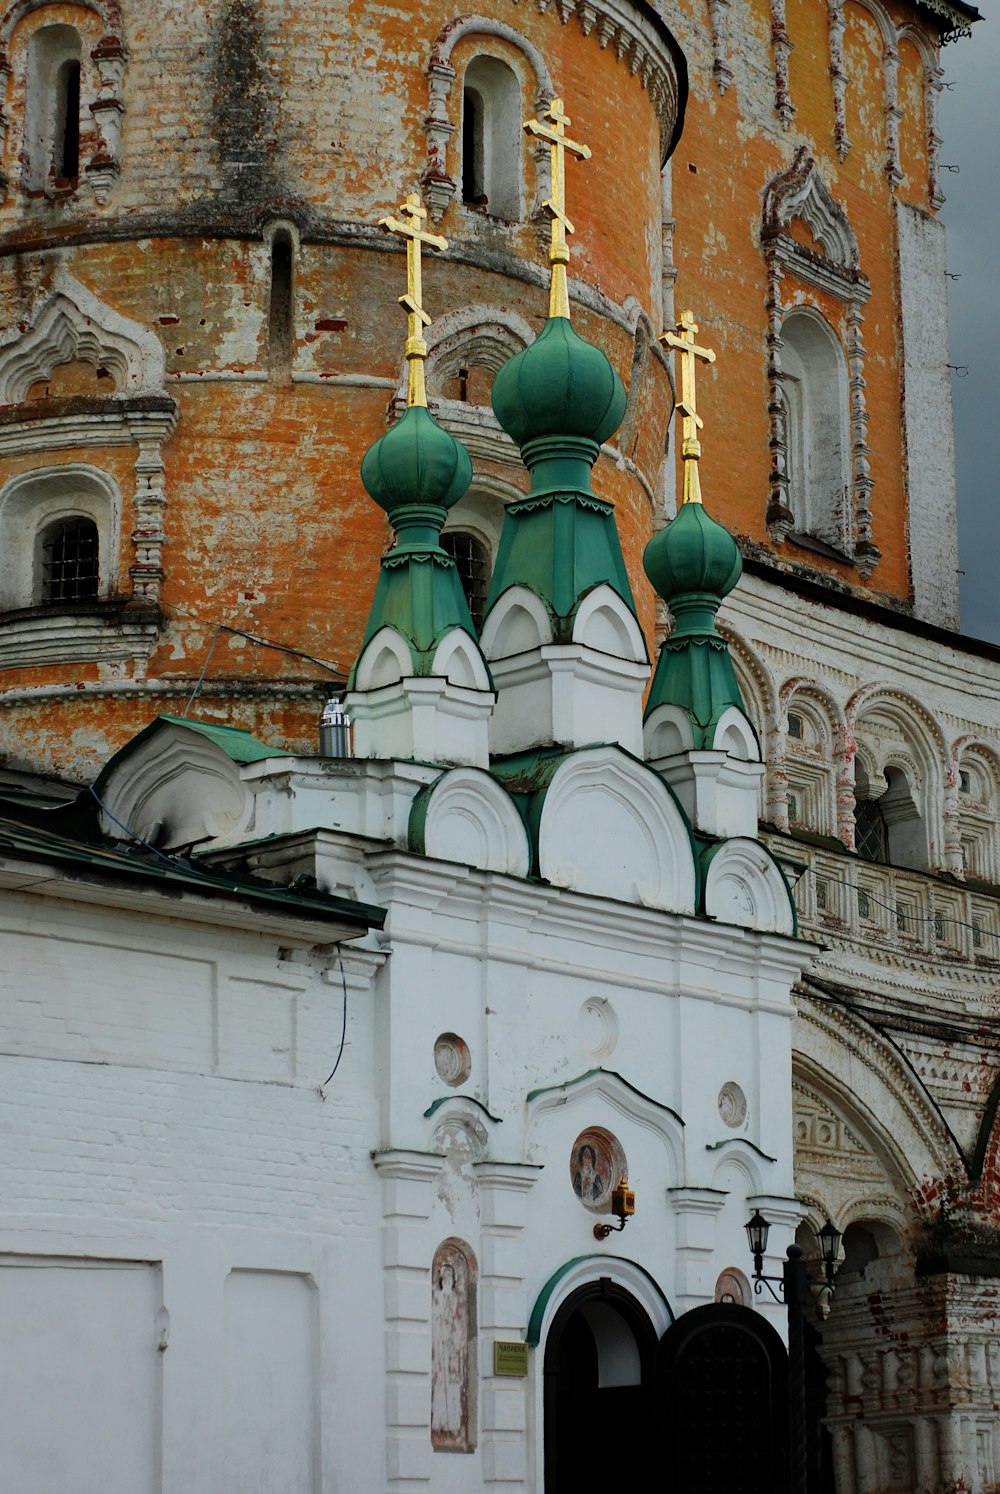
[744,1209,842,1494]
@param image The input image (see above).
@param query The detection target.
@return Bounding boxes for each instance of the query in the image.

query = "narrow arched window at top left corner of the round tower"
[24,25,81,191]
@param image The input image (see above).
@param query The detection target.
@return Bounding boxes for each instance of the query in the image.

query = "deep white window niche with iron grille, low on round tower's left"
[0,463,121,611]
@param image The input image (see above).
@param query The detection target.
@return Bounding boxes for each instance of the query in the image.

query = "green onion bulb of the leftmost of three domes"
[362,405,472,514]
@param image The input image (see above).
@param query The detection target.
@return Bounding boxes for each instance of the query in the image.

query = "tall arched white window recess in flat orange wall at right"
[782,306,851,551]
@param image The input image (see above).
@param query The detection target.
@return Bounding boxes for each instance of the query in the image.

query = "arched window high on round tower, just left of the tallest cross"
[462,57,522,223]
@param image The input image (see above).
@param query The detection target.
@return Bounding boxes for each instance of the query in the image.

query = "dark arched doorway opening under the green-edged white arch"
[544,1277,656,1494]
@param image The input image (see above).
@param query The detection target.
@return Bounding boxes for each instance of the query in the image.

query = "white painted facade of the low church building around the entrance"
[0,693,809,1494]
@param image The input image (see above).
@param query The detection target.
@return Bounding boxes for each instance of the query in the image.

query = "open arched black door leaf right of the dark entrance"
[655,1303,788,1494]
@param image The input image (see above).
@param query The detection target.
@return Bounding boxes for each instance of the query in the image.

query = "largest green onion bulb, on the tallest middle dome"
[493,317,625,447]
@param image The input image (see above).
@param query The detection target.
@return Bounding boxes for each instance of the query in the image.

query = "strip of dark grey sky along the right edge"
[940,18,1000,642]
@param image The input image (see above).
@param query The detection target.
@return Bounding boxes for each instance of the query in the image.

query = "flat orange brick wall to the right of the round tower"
[673,0,931,604]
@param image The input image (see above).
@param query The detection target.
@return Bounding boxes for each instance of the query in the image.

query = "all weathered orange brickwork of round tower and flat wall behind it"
[0,0,950,777]
